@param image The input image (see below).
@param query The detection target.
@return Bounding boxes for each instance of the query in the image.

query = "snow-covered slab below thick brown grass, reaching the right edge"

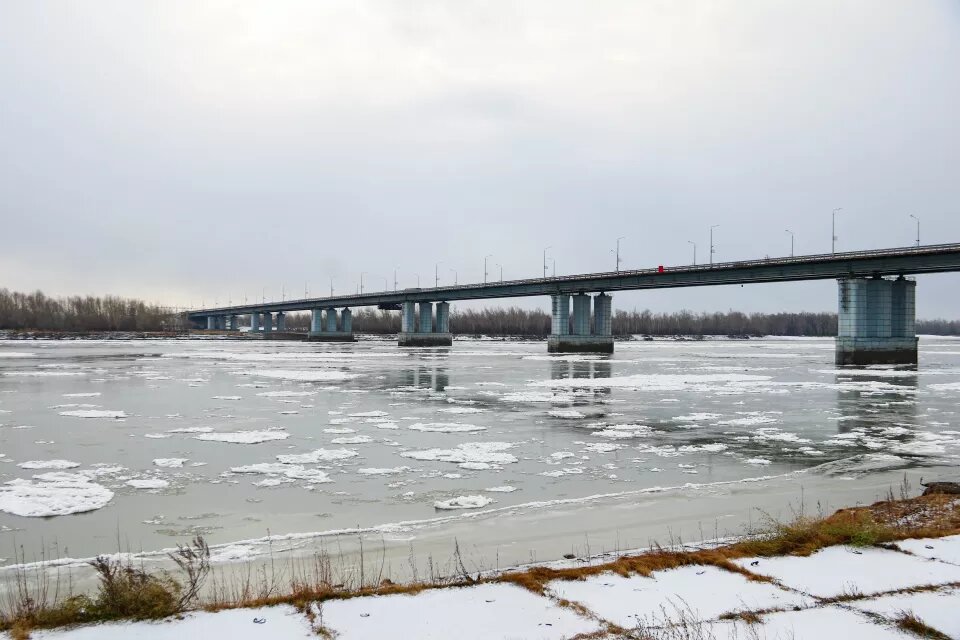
[734,546,960,598]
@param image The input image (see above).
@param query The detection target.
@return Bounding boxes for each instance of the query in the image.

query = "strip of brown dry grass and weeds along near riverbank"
[0,495,960,640]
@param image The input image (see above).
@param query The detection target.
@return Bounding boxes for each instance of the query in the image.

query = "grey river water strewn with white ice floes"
[0,337,960,565]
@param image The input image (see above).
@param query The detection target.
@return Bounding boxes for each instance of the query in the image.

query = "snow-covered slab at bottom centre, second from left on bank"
[318,584,599,640]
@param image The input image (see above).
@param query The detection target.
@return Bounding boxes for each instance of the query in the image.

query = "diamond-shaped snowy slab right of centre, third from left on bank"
[547,566,811,629]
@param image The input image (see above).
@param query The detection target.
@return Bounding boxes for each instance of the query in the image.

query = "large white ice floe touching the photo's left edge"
[0,474,113,518]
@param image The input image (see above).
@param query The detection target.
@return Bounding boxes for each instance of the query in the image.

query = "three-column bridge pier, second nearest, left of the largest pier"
[547,293,613,353]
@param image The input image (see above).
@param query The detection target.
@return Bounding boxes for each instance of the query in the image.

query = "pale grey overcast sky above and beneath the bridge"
[0,0,960,317]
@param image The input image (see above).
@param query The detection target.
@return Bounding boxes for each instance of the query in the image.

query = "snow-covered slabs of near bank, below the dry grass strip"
[18,536,960,640]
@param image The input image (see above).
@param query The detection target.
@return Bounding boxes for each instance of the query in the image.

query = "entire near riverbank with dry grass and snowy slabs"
[0,487,960,640]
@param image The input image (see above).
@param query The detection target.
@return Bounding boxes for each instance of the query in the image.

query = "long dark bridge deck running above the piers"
[189,244,960,317]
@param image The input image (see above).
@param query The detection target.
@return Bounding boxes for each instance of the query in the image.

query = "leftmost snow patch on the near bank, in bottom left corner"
[30,605,317,640]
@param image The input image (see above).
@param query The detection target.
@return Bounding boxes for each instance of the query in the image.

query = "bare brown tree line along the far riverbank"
[0,289,960,338]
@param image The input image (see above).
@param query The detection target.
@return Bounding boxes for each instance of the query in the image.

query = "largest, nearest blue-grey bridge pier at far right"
[836,278,917,365]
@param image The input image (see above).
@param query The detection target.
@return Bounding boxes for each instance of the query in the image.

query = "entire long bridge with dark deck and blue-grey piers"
[188,244,960,364]
